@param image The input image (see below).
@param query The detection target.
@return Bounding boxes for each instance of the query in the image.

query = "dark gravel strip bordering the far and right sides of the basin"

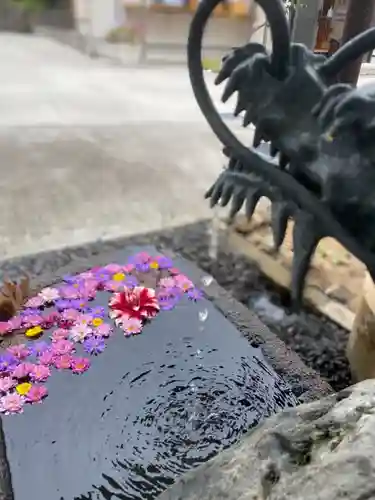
[0,221,352,391]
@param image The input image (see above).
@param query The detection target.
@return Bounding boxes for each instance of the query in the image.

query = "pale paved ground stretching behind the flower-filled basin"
[0,34,249,259]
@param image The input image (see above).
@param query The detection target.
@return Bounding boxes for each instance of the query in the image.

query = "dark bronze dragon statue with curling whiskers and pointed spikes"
[188,0,375,306]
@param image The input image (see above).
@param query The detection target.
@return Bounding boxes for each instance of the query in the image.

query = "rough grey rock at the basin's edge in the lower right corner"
[158,380,375,500]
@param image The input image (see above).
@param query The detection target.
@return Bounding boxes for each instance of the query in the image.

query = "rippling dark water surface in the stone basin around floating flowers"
[2,248,296,500]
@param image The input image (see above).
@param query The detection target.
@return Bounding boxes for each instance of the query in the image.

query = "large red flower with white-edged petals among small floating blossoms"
[109,286,160,325]
